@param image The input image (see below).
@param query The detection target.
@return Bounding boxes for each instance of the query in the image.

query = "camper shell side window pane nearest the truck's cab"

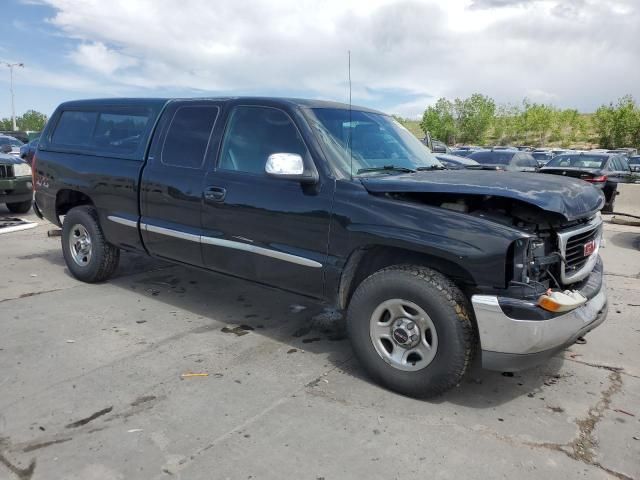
[94,112,149,153]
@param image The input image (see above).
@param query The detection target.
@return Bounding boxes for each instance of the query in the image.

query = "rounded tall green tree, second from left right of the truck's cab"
[453,93,496,143]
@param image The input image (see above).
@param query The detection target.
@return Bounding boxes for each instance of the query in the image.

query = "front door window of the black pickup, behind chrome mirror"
[219,106,309,174]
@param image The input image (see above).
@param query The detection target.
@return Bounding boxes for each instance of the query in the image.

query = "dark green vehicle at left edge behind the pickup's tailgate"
[0,153,33,213]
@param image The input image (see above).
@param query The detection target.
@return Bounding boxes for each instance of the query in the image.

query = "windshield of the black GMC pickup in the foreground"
[309,108,442,176]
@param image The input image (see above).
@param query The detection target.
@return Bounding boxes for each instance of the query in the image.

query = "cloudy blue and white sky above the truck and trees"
[0,0,640,118]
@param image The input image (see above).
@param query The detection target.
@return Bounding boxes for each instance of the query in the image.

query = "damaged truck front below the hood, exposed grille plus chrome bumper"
[391,189,607,371]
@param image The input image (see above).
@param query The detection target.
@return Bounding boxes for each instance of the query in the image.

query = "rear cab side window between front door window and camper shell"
[161,105,218,168]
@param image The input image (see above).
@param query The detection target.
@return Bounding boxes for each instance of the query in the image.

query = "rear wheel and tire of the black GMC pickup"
[62,206,120,283]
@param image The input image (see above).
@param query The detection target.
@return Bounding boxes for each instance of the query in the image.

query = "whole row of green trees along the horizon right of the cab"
[420,93,640,148]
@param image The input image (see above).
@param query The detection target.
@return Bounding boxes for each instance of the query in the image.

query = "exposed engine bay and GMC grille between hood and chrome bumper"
[388,192,602,306]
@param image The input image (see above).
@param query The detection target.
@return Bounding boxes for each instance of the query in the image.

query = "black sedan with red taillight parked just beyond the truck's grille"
[540,152,632,211]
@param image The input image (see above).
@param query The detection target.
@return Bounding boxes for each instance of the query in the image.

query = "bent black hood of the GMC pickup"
[360,170,604,221]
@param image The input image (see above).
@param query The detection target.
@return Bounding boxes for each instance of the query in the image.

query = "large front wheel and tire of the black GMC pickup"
[347,265,477,398]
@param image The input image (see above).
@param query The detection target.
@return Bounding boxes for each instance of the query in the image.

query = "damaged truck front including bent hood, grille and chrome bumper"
[361,171,607,371]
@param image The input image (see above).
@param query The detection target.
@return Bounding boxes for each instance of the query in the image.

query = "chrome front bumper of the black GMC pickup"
[471,258,608,372]
